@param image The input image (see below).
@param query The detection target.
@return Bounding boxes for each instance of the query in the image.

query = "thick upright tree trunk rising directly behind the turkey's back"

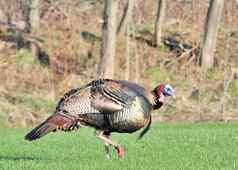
[97,0,118,78]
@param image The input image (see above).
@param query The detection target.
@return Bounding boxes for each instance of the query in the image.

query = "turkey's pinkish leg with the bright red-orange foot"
[96,131,124,157]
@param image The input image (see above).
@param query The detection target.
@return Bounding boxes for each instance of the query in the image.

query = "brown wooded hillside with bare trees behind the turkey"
[0,0,238,127]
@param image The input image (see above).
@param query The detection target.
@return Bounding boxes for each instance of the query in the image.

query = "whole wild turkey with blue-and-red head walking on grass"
[25,79,173,157]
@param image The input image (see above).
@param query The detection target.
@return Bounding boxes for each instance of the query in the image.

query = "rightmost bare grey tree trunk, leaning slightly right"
[200,0,224,69]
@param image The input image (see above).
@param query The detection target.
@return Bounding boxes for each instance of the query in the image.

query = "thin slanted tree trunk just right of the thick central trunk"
[117,0,136,34]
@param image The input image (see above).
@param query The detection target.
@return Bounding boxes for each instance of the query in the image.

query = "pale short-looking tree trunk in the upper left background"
[29,0,40,32]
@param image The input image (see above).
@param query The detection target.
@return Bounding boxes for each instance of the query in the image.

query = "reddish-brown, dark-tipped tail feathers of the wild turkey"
[25,112,78,141]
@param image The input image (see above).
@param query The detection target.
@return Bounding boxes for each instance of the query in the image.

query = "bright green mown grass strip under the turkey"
[0,123,238,170]
